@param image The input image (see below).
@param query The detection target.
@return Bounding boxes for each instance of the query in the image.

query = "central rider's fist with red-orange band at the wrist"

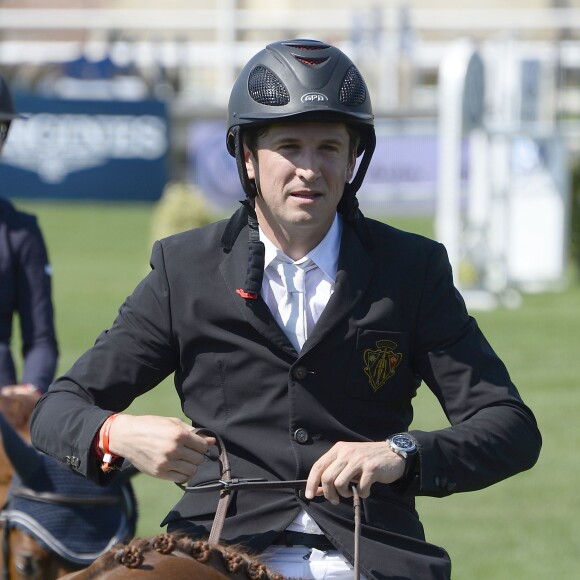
[100,414,216,483]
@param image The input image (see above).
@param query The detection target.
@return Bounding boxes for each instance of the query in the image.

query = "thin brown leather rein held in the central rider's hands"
[176,428,361,580]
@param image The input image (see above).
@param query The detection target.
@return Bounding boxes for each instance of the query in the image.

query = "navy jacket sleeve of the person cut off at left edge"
[14,214,58,392]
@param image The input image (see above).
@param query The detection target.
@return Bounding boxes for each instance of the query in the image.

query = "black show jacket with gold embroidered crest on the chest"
[32,208,541,580]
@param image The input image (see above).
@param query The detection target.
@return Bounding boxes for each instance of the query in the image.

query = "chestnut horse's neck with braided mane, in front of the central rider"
[62,534,284,580]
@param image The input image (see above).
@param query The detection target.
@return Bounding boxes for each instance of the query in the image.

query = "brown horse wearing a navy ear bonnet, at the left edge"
[0,393,137,580]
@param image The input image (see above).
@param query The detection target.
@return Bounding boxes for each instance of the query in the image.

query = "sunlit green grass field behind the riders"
[11,201,580,580]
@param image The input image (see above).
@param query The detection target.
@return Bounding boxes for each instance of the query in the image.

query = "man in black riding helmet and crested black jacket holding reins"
[32,40,541,580]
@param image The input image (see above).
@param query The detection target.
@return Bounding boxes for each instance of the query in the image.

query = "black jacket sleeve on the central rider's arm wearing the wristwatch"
[407,244,541,496]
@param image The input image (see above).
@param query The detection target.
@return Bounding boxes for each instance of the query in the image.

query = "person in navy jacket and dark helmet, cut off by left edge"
[0,76,58,396]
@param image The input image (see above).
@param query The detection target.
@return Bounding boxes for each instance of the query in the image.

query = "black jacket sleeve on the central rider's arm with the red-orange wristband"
[31,243,177,483]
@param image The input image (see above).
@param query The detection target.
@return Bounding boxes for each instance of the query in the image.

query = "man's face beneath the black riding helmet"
[245,123,356,239]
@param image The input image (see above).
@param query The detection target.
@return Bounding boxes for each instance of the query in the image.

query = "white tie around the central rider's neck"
[276,259,316,352]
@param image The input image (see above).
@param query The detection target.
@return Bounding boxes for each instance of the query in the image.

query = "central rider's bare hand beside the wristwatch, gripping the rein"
[306,441,405,504]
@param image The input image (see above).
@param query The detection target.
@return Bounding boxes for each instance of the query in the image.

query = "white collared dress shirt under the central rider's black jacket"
[260,214,342,534]
